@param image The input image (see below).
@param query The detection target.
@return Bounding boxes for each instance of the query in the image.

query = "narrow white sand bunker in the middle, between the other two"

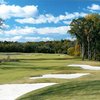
[30,73,89,79]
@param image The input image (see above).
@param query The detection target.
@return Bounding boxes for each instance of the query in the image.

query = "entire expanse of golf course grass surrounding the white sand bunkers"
[0,53,100,100]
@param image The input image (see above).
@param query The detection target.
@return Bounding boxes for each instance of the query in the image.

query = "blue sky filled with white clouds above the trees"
[0,0,100,42]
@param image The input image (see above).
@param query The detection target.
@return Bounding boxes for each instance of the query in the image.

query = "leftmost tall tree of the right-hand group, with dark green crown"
[69,18,86,60]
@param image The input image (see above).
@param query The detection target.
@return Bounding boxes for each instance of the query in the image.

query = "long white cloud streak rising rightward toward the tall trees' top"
[15,12,86,24]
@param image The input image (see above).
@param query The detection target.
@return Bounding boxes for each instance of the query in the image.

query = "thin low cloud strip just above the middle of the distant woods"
[24,37,53,41]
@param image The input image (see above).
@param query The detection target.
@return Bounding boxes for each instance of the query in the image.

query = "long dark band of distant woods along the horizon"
[0,40,75,54]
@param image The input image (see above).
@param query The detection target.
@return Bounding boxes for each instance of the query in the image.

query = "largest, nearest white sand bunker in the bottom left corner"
[0,83,56,100]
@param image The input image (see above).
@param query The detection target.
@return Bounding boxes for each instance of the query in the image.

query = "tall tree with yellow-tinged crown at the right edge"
[85,14,100,60]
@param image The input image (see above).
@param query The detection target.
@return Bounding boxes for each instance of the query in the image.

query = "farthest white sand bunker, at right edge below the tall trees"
[68,64,100,70]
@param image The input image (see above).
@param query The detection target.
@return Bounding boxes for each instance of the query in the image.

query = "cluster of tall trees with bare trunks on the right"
[69,14,100,60]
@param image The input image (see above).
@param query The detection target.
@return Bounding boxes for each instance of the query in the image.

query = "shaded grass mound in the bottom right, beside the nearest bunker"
[18,80,100,100]
